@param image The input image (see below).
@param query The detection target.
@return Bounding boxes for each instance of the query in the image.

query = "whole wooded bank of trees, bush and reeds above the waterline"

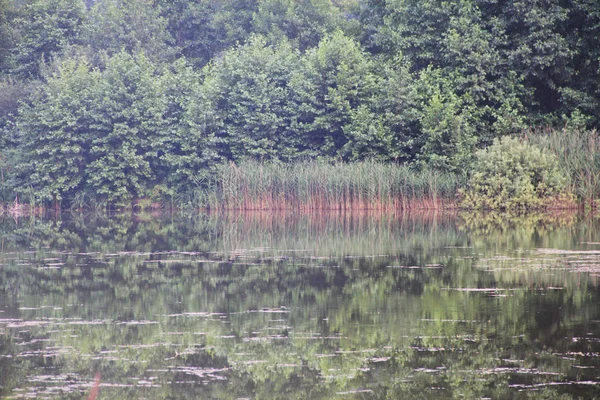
[0,0,600,208]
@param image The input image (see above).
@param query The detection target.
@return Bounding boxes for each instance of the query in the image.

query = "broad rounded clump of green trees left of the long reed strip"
[14,52,214,204]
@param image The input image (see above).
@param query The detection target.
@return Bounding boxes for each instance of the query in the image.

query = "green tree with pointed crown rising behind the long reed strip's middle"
[292,31,384,160]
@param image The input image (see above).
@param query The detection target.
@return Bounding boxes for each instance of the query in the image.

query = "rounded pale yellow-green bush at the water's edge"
[461,137,572,210]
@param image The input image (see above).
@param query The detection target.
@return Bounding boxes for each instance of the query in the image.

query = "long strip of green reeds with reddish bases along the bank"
[202,161,463,212]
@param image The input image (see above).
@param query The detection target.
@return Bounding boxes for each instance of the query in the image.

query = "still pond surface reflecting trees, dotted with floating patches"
[0,213,600,399]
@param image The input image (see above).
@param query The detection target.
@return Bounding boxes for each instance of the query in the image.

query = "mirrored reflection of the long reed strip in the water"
[218,210,462,257]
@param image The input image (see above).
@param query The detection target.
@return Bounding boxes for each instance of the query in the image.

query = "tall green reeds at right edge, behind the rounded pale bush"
[524,126,600,206]
